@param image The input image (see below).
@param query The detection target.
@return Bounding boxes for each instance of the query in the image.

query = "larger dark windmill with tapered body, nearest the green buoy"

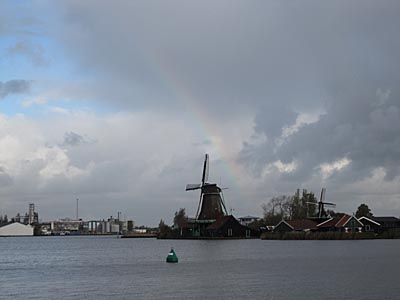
[186,154,227,220]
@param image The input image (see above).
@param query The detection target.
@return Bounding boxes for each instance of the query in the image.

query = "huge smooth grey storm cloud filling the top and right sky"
[52,1,400,180]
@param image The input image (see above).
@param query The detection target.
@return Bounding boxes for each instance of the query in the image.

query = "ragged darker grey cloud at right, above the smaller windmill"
[243,87,400,182]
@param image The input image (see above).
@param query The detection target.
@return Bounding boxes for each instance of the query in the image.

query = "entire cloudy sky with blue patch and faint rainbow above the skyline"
[0,0,400,225]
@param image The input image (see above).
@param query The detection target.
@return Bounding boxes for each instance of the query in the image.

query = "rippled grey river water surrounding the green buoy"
[0,236,400,300]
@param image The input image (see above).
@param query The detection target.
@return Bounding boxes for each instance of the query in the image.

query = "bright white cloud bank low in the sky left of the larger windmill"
[0,111,252,223]
